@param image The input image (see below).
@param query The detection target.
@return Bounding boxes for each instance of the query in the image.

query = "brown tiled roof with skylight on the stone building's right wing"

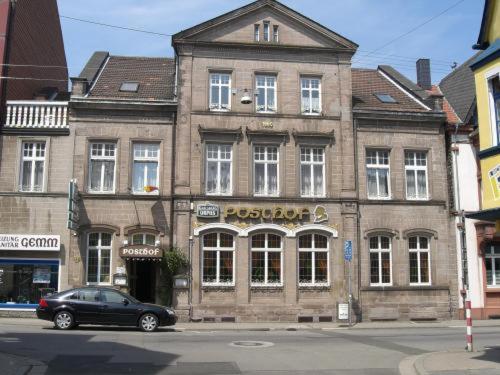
[352,66,430,112]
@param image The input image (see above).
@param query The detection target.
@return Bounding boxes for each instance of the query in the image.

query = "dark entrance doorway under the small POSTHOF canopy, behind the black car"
[128,260,157,303]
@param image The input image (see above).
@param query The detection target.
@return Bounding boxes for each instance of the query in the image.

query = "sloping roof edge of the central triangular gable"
[172,0,358,50]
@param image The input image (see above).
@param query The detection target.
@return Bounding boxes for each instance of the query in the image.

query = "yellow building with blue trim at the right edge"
[470,0,500,229]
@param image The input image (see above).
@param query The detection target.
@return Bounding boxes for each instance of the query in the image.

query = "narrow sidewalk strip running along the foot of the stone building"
[0,318,500,331]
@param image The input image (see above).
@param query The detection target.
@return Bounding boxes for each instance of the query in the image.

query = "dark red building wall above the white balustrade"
[0,0,68,100]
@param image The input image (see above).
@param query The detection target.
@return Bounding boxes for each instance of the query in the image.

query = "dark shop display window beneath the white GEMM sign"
[0,259,59,308]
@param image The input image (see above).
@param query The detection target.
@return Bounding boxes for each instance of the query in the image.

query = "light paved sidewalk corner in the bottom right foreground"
[399,346,500,375]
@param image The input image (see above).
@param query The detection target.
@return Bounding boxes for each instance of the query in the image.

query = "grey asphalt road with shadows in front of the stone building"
[0,323,500,375]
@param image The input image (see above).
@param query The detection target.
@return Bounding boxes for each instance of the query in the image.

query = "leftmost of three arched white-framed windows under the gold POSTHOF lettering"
[202,232,235,286]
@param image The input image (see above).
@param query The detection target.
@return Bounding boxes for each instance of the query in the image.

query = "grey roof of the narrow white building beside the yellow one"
[439,52,480,124]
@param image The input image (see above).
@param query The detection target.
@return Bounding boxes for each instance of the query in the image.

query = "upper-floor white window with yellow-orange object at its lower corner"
[132,143,160,194]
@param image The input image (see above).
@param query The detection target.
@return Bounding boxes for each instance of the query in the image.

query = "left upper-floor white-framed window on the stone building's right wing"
[366,150,391,199]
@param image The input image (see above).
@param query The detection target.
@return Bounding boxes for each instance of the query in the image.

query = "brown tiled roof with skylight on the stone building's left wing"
[86,56,175,100]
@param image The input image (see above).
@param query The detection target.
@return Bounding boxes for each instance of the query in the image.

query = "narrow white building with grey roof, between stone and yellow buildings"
[439,57,494,319]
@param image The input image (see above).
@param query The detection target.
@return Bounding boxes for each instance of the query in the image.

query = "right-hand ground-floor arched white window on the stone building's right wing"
[408,236,431,285]
